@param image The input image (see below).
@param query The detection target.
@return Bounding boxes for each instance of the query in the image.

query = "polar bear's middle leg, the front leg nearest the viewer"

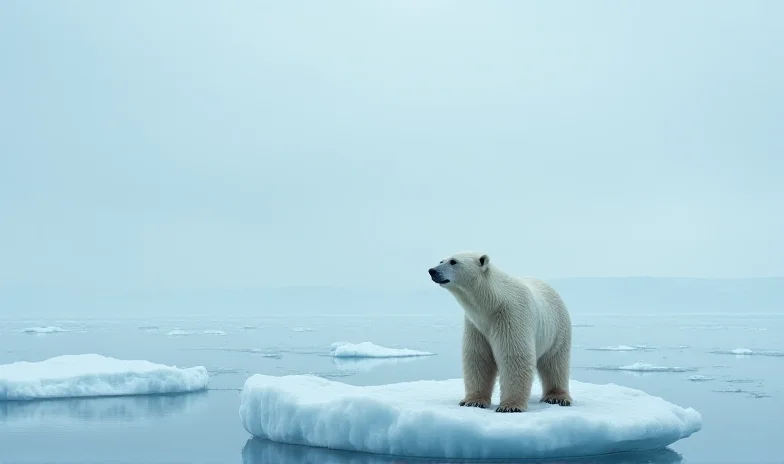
[496,332,536,412]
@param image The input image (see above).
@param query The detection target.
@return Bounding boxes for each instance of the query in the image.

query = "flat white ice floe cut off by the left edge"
[0,354,209,401]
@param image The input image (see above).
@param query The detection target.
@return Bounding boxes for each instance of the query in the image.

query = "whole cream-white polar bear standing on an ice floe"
[428,252,572,412]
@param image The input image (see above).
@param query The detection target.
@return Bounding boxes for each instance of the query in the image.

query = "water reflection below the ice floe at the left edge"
[0,391,208,423]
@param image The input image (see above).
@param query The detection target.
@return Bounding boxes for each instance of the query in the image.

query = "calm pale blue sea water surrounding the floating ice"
[0,311,784,463]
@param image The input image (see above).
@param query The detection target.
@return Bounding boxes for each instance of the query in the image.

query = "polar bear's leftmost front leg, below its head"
[459,318,498,408]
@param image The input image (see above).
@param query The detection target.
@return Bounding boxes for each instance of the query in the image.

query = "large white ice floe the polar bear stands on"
[239,374,702,459]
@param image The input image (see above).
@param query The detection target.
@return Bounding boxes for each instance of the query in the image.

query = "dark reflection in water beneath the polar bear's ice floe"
[242,438,682,464]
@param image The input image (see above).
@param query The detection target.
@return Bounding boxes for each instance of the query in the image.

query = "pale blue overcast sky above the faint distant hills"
[0,0,784,291]
